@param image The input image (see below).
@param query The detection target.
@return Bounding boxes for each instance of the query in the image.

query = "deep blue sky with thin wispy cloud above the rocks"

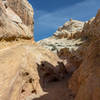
[28,0,100,41]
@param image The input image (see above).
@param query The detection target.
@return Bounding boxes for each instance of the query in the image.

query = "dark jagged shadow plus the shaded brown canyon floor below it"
[32,61,75,100]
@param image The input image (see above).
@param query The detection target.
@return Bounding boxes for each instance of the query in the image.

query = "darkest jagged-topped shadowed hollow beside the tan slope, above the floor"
[37,61,67,88]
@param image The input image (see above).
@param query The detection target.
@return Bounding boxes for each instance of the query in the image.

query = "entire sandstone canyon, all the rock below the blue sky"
[0,0,100,100]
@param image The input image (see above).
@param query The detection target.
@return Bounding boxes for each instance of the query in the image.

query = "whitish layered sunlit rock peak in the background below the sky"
[38,20,84,53]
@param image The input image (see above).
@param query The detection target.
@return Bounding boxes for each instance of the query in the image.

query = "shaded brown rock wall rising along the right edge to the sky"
[69,10,100,100]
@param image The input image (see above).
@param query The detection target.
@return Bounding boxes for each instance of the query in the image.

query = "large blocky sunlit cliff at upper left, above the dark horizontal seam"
[0,0,34,40]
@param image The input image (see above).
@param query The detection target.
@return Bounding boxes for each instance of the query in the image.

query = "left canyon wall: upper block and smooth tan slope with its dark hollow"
[0,0,66,100]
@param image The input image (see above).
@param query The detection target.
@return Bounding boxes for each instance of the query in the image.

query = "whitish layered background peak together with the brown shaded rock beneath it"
[38,19,84,73]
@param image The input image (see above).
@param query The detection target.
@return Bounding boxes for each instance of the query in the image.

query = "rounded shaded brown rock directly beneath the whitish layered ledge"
[57,48,82,73]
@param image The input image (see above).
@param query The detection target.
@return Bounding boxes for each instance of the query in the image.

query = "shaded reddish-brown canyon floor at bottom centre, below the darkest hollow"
[30,75,74,100]
